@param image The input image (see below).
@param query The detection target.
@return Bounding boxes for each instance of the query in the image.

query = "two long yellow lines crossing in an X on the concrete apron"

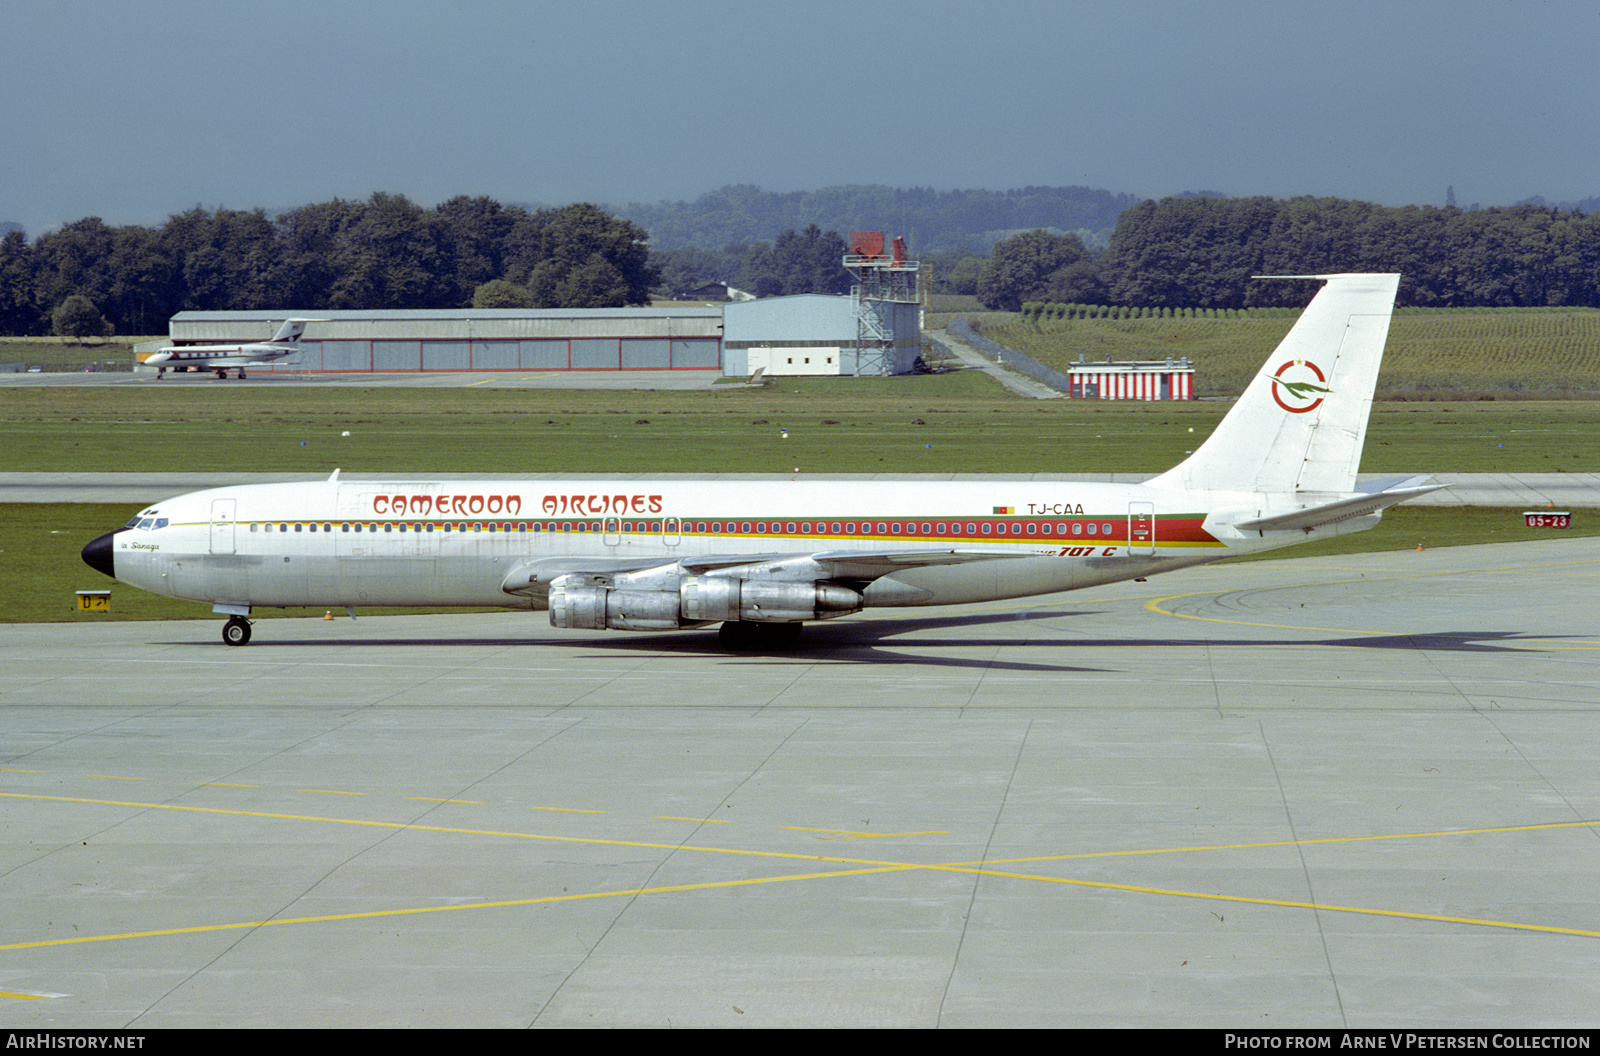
[0,792,1600,950]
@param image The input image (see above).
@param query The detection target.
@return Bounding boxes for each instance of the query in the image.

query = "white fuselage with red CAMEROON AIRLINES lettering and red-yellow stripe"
[103,478,1376,608]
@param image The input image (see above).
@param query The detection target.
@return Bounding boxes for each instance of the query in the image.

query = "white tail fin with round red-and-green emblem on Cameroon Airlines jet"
[1149,275,1400,493]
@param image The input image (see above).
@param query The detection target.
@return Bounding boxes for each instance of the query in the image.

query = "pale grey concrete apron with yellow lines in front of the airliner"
[0,539,1600,1029]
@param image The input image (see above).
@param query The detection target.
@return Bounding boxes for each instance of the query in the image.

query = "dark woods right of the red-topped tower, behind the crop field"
[952,197,1600,310]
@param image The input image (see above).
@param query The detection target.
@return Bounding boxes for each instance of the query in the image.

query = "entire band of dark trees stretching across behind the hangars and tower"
[12,189,1600,334]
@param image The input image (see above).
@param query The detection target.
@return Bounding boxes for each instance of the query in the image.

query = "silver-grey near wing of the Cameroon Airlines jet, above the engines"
[501,547,1034,597]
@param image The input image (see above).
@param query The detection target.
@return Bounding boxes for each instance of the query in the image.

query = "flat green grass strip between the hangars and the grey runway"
[0,371,1600,475]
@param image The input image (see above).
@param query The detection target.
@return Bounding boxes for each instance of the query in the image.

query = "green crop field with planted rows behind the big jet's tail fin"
[981,309,1600,400]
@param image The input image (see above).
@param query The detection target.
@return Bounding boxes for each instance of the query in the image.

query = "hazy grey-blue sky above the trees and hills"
[0,0,1600,237]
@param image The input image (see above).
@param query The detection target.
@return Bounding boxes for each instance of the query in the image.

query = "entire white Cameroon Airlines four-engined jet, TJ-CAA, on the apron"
[83,275,1435,650]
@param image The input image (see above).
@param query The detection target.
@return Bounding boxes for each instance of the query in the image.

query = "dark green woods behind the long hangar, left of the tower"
[0,194,659,334]
